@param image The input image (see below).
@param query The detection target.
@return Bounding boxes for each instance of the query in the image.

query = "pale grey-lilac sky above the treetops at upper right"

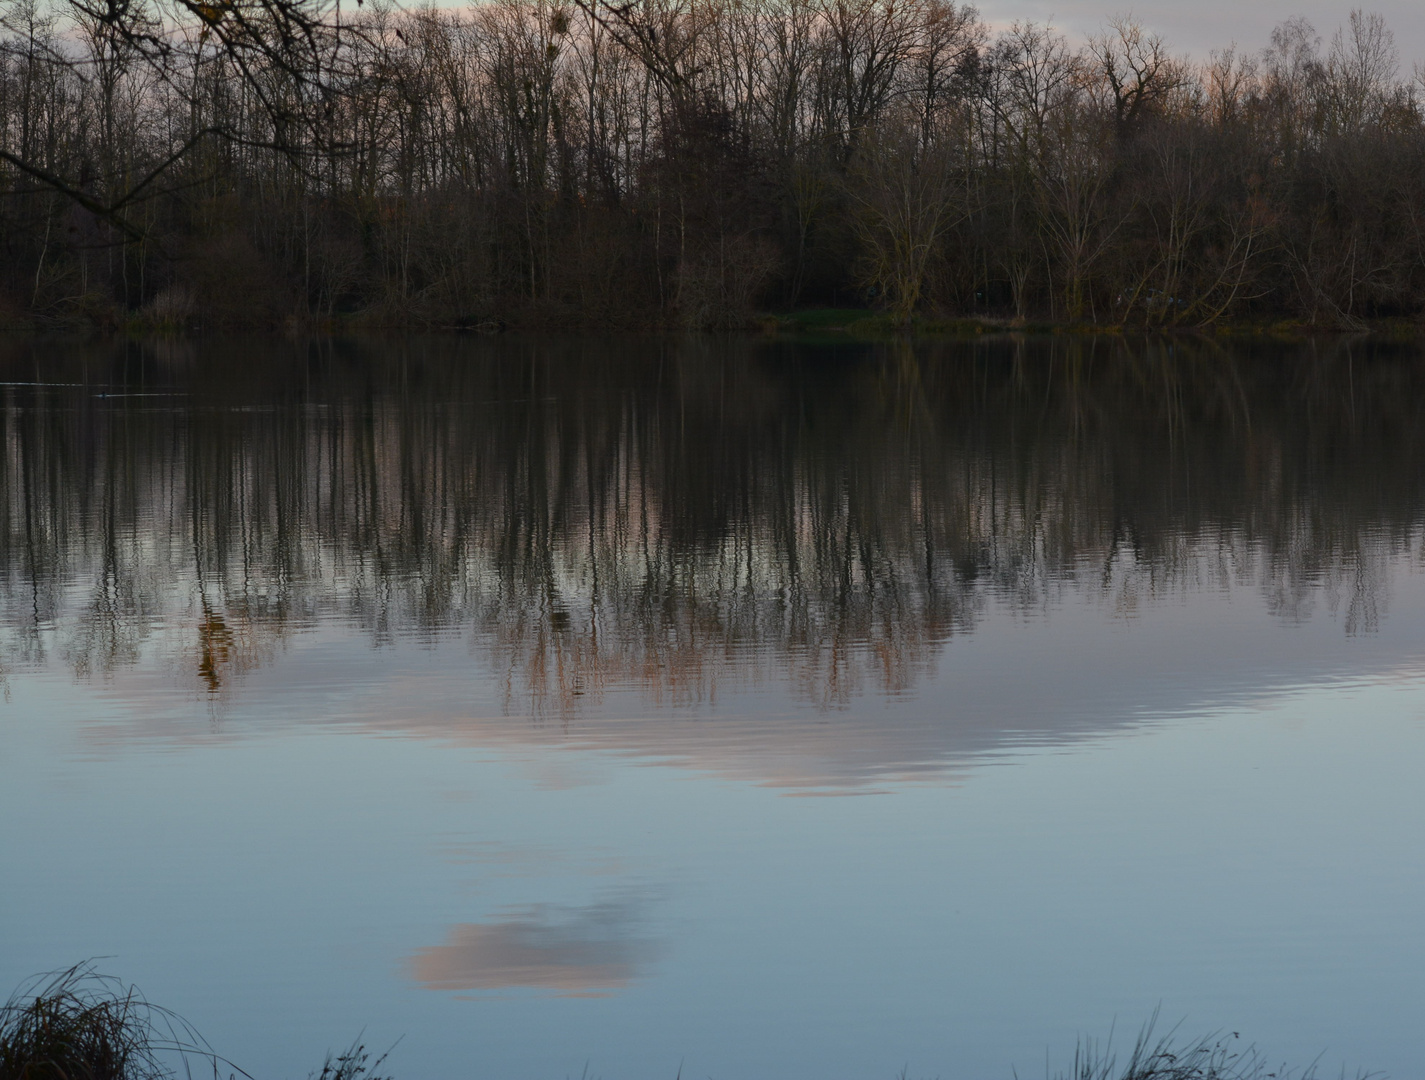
[978,0,1425,74]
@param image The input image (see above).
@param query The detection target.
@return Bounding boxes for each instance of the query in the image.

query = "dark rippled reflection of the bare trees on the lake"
[0,339,1425,711]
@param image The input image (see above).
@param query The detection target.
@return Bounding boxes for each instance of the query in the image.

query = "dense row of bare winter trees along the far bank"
[8,0,1425,326]
